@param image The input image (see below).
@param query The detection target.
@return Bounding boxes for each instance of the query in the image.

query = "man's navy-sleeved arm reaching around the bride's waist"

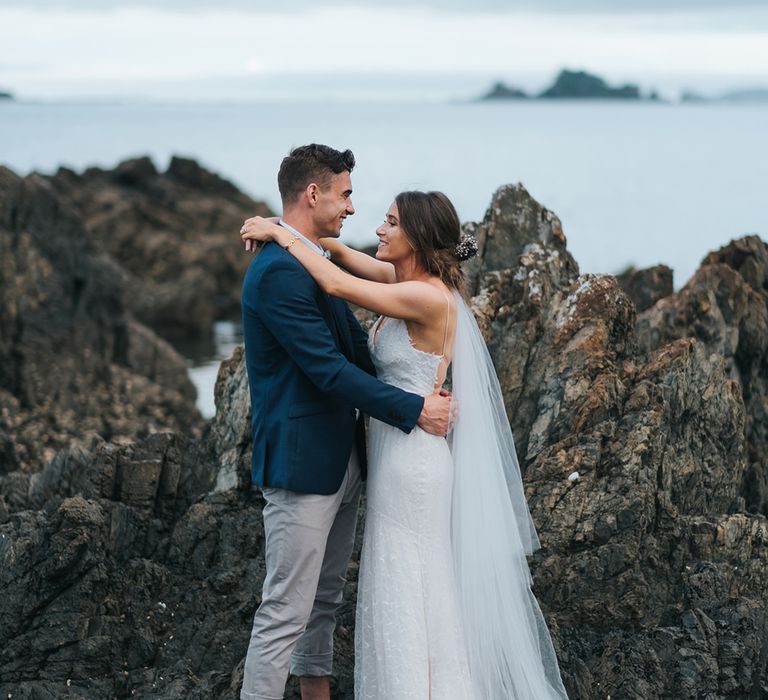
[255,259,424,433]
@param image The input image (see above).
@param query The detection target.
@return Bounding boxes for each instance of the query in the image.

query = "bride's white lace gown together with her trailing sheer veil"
[355,306,567,700]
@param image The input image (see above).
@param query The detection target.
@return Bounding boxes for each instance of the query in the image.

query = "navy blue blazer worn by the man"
[242,243,424,494]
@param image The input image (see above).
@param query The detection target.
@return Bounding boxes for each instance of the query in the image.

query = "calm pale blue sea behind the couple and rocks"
[0,101,768,416]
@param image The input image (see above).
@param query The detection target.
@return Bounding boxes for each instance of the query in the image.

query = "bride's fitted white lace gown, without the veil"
[355,318,479,700]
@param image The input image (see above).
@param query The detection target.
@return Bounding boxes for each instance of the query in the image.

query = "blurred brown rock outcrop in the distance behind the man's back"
[49,157,271,341]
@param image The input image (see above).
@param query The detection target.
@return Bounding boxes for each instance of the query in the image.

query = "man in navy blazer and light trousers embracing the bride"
[240,144,450,700]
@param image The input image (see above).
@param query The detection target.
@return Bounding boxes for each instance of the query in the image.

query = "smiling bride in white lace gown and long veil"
[242,192,567,700]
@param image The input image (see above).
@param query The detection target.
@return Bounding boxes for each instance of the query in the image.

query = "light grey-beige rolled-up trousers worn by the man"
[240,449,361,700]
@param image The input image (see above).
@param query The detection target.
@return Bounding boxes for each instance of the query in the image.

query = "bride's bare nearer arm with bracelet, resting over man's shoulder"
[240,219,445,323]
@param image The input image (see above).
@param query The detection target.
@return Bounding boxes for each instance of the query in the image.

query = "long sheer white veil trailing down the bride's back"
[449,294,568,700]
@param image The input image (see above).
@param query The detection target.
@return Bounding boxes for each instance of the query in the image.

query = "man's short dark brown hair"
[277,143,355,207]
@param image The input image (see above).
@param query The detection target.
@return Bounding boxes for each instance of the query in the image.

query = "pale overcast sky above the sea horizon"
[0,0,768,99]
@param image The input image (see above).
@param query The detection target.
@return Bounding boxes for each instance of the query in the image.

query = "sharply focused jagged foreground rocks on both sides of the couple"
[0,185,768,700]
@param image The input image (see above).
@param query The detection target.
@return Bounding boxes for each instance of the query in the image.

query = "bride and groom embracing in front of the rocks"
[241,144,566,700]
